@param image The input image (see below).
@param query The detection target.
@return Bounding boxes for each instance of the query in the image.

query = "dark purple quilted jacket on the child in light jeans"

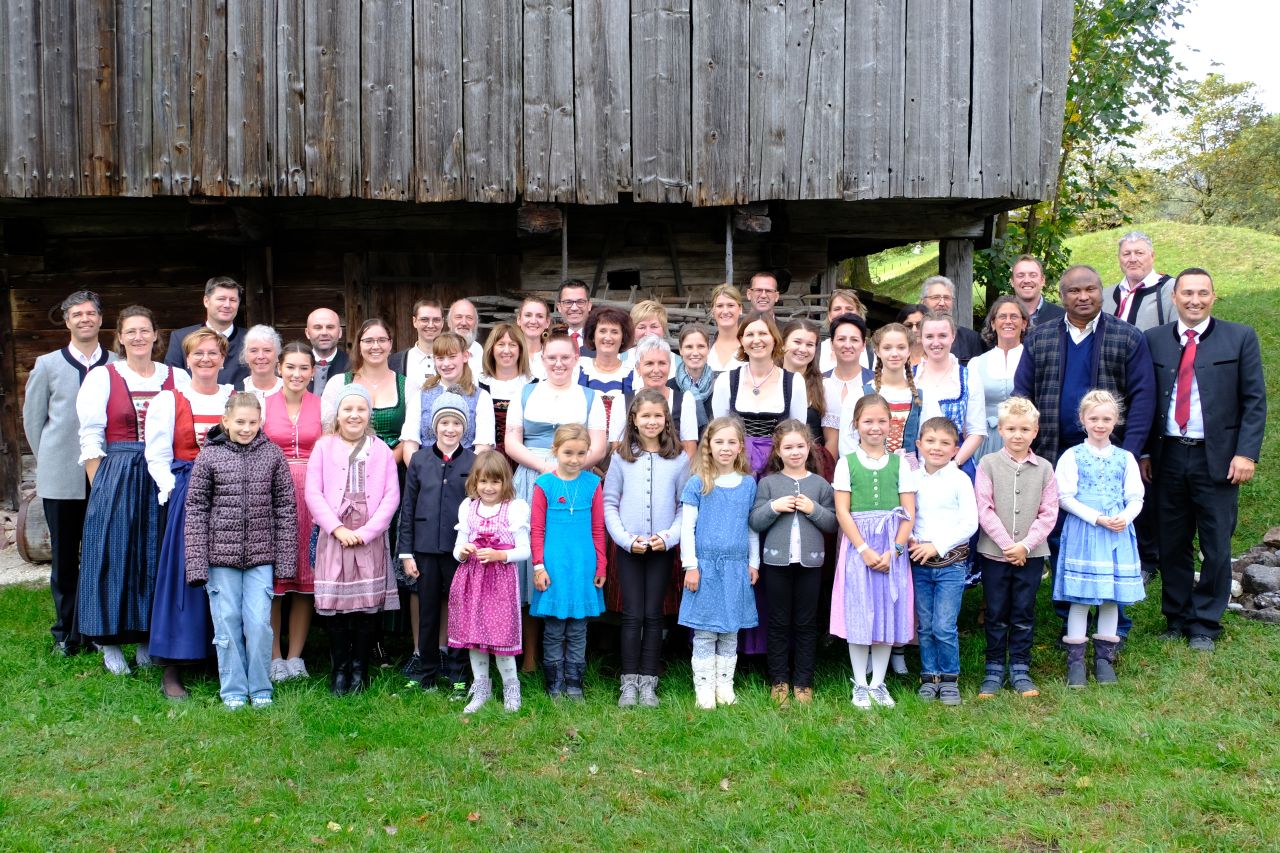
[186,430,298,587]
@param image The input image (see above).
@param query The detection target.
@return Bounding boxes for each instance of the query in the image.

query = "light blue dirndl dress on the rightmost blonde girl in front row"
[1053,444,1146,605]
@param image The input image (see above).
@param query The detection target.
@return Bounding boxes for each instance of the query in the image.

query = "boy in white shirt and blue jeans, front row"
[910,418,978,704]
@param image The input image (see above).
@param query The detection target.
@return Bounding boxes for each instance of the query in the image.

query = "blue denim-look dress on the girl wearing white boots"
[680,475,759,634]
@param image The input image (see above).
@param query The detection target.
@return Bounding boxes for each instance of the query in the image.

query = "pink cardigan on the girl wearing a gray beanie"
[307,435,399,542]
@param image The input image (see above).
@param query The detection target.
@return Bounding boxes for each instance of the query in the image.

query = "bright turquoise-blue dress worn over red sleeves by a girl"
[529,471,604,619]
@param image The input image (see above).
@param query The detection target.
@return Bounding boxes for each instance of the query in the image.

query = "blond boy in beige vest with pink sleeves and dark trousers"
[974,397,1059,699]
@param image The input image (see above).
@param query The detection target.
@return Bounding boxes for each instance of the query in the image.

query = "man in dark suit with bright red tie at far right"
[1142,266,1267,652]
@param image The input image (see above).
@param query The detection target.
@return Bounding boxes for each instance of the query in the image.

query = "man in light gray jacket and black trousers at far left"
[22,291,116,656]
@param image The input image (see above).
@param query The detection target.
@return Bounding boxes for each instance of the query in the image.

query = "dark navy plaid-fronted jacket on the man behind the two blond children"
[1014,313,1156,464]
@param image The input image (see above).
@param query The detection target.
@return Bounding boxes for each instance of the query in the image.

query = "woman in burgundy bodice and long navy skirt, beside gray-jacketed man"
[76,305,191,675]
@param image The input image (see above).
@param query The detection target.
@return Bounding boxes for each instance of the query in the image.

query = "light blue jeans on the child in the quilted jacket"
[206,566,273,702]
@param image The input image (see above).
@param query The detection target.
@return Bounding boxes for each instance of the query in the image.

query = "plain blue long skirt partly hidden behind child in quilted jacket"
[150,459,214,661]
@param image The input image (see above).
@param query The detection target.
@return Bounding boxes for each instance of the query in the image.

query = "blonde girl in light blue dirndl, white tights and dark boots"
[1053,391,1146,688]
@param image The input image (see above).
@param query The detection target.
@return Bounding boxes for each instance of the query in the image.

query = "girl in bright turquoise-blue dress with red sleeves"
[529,424,605,701]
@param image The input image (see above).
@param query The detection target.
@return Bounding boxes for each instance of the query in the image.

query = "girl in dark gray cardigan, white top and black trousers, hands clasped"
[750,420,836,706]
